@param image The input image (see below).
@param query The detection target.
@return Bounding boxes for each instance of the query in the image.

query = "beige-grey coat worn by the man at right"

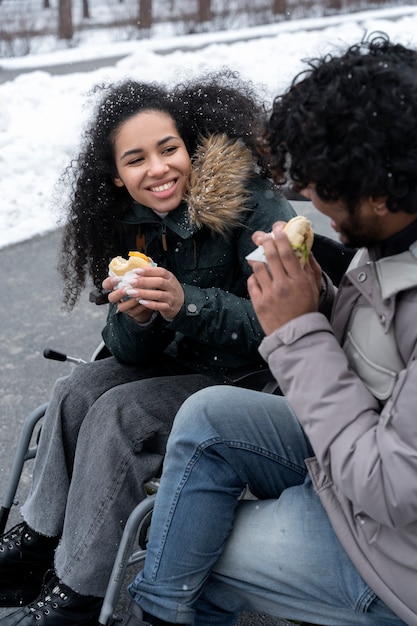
[260,244,417,626]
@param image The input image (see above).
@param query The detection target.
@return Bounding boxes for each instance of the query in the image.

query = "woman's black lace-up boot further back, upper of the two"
[0,522,58,606]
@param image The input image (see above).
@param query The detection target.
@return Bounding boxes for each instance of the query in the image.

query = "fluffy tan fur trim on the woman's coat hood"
[185,134,255,234]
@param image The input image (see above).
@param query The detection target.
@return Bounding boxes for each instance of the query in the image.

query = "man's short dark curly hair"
[260,33,417,213]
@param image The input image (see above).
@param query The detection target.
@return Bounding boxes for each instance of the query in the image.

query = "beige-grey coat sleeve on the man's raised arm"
[260,313,417,528]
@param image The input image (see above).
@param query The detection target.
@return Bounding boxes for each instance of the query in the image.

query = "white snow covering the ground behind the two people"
[0,6,417,248]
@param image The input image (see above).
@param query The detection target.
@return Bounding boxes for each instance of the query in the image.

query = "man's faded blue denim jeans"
[129,387,404,626]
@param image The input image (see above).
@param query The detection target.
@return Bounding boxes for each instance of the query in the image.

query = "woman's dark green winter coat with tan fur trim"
[103,133,295,378]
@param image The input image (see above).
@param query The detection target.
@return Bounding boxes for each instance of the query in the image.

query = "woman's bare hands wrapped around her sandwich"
[103,267,184,324]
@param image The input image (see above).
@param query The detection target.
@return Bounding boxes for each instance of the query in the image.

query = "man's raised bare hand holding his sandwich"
[248,222,321,335]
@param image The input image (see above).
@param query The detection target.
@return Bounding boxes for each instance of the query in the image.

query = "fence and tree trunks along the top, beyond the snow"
[0,0,417,57]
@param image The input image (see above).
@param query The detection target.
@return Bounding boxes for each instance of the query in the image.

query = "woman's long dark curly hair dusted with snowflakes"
[55,69,268,310]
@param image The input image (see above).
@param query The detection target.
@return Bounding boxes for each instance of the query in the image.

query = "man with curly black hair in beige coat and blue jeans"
[113,34,417,626]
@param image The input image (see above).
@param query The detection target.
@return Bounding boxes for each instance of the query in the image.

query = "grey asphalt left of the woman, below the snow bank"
[0,231,106,510]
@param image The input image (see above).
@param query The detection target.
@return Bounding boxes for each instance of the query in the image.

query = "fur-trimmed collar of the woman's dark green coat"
[117,134,255,238]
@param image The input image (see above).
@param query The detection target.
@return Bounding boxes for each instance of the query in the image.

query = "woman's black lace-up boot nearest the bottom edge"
[0,570,103,626]
